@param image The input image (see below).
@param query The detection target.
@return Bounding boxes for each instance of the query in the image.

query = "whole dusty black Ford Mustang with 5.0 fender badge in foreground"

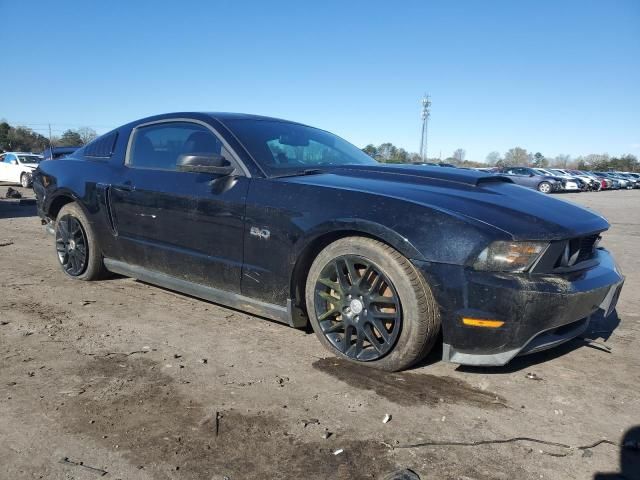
[34,113,623,370]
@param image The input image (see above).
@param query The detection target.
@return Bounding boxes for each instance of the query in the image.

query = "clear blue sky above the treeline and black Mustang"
[0,0,640,161]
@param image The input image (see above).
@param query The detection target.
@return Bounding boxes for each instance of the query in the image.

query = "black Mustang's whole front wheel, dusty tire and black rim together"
[305,237,440,371]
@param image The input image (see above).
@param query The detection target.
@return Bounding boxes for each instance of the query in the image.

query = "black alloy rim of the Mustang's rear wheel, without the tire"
[56,215,89,277]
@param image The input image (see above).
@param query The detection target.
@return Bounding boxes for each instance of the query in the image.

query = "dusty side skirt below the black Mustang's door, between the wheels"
[104,258,302,327]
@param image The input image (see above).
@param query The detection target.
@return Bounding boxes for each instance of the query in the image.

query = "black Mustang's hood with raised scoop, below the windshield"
[280,165,609,240]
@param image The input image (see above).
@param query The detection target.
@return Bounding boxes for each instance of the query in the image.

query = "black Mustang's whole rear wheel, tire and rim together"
[55,202,107,281]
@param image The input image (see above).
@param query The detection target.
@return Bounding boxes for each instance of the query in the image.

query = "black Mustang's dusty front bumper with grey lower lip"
[416,249,624,366]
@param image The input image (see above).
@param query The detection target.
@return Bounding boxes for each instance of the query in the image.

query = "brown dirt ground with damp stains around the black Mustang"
[0,186,640,480]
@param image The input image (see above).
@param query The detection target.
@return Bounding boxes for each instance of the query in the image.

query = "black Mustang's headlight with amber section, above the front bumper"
[473,241,549,272]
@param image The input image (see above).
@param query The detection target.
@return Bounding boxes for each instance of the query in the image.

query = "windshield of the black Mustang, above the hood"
[225,119,378,176]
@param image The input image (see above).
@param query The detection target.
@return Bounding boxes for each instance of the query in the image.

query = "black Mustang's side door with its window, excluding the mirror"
[108,120,249,293]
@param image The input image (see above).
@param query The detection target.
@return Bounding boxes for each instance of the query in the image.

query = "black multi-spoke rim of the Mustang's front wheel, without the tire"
[314,255,402,361]
